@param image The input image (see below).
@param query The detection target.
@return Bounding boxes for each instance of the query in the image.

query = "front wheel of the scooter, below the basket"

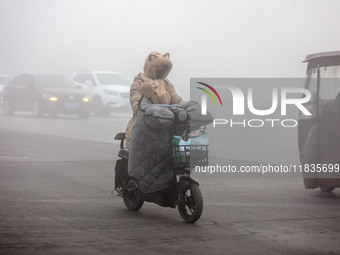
[178,183,203,223]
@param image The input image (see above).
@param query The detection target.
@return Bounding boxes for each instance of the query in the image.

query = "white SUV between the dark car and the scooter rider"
[73,71,132,116]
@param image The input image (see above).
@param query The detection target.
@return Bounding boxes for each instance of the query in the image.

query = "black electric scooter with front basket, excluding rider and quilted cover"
[114,105,209,223]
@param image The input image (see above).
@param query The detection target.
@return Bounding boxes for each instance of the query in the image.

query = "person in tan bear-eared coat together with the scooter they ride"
[114,52,212,223]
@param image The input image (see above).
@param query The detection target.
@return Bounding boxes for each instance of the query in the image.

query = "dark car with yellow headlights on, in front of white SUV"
[3,74,91,118]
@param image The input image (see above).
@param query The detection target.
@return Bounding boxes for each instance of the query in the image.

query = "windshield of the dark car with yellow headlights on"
[34,75,75,88]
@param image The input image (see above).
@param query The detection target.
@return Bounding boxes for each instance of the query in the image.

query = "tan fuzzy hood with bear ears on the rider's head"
[144,51,172,80]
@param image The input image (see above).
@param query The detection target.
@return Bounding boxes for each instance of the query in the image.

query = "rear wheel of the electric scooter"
[123,179,144,211]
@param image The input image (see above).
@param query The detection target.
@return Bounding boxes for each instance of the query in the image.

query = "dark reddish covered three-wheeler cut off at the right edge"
[298,51,340,192]
